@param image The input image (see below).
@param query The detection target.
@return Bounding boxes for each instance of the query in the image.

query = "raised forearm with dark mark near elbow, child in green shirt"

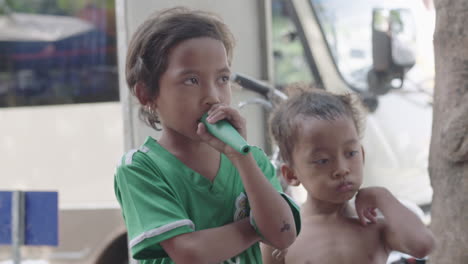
[233,154,296,249]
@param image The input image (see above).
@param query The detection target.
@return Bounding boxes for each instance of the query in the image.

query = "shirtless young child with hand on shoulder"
[263,88,435,264]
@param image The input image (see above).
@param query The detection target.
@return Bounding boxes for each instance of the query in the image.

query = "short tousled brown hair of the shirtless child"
[269,84,364,165]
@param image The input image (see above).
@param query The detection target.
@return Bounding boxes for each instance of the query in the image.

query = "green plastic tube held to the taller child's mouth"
[200,113,250,155]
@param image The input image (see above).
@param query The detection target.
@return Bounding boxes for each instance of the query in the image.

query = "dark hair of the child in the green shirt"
[125,7,234,130]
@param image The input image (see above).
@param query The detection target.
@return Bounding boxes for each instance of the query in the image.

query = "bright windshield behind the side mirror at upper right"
[310,0,434,90]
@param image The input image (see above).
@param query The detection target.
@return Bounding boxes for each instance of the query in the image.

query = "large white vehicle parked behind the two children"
[0,0,433,264]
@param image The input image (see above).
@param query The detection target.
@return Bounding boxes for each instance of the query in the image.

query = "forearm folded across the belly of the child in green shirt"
[161,218,260,263]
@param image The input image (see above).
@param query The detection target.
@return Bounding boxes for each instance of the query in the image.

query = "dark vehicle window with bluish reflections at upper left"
[0,0,119,107]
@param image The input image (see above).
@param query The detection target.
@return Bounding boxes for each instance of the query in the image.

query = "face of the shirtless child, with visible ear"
[283,117,364,203]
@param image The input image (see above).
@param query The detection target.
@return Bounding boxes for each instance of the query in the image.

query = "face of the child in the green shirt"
[154,37,231,140]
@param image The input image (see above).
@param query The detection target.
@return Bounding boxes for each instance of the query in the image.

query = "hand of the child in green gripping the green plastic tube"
[197,104,246,156]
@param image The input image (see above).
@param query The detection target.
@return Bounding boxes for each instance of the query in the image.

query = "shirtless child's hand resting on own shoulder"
[355,187,383,226]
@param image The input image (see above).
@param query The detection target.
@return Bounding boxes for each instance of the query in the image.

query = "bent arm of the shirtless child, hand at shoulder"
[356,187,435,258]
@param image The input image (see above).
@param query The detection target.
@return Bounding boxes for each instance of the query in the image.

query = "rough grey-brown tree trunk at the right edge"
[429,0,468,264]
